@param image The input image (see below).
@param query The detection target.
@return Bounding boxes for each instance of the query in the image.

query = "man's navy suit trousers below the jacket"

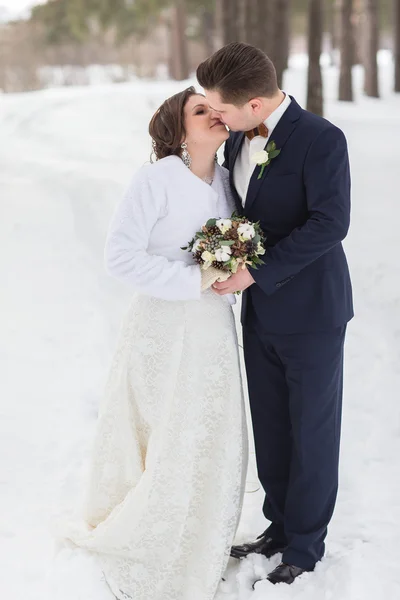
[243,307,346,569]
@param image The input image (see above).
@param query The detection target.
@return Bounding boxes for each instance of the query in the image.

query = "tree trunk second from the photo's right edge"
[364,0,379,98]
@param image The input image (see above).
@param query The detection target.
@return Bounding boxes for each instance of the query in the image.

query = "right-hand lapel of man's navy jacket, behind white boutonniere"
[245,96,303,211]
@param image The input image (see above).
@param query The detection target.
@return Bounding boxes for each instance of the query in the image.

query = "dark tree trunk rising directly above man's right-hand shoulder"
[307,0,324,115]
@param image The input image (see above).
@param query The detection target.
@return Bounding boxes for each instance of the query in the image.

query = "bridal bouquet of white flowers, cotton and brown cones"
[182,213,265,274]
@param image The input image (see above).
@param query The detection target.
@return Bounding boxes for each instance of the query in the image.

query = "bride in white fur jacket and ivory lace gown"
[63,88,247,600]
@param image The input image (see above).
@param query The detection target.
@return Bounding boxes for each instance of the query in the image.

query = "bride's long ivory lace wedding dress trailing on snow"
[61,158,247,600]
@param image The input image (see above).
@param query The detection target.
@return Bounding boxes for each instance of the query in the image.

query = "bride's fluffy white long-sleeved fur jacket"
[105,156,235,304]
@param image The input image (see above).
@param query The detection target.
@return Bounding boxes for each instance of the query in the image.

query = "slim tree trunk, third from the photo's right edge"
[339,0,354,102]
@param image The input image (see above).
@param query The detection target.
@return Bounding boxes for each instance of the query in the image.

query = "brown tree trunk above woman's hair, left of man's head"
[170,0,189,81]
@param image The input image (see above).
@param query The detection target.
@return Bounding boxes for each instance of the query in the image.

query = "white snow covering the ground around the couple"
[0,55,400,600]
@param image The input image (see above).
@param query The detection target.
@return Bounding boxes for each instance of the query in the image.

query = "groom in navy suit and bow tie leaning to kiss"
[197,43,353,583]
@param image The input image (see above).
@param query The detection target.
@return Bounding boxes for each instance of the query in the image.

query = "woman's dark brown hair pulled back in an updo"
[149,86,197,162]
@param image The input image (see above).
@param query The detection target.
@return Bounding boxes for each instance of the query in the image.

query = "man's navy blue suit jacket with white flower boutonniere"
[224,98,353,334]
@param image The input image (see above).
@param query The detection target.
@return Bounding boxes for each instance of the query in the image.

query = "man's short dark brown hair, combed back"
[197,42,279,106]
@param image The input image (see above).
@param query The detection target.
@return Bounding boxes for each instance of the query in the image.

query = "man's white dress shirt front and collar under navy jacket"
[233,94,291,206]
